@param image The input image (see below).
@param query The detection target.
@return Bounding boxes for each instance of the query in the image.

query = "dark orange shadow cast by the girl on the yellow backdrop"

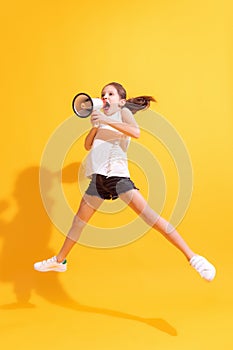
[0,163,177,336]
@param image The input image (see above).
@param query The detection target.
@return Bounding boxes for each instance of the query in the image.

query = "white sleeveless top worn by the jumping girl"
[86,111,130,177]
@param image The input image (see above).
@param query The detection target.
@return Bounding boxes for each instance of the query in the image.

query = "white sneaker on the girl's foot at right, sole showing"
[189,255,216,281]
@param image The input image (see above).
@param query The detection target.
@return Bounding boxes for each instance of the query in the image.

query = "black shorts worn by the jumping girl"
[86,174,138,199]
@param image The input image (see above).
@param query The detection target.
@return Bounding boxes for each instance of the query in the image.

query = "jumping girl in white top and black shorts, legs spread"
[34,82,216,281]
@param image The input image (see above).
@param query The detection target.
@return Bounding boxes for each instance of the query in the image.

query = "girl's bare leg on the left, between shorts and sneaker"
[57,194,103,262]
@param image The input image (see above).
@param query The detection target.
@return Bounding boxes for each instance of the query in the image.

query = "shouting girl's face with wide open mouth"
[101,85,125,115]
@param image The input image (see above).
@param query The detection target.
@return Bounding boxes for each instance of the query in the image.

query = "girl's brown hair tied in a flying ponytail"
[102,82,156,114]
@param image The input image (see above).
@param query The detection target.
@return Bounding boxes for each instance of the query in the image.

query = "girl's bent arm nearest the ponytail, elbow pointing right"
[91,108,140,138]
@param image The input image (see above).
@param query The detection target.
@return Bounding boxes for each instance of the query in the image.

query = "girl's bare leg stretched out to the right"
[119,190,195,260]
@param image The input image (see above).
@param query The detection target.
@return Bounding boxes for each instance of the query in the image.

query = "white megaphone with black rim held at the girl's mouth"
[72,92,104,118]
